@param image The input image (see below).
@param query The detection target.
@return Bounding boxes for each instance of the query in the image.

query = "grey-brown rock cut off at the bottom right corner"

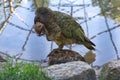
[100,60,120,80]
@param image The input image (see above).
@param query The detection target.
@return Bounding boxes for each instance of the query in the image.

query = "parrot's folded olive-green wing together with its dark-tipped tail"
[54,11,95,50]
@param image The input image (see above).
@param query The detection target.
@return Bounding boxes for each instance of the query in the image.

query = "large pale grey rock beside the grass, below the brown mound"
[44,61,96,80]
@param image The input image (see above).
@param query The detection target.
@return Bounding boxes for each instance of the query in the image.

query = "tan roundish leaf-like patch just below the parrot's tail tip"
[84,50,96,64]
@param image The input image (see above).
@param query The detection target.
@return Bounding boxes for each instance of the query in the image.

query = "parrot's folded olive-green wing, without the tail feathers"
[54,11,84,40]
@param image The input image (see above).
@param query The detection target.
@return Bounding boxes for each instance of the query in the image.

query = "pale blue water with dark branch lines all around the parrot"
[0,0,120,65]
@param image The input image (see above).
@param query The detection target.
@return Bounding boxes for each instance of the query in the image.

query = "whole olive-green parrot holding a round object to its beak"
[34,7,95,50]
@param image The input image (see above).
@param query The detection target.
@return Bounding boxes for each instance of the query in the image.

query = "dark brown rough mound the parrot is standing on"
[48,49,85,65]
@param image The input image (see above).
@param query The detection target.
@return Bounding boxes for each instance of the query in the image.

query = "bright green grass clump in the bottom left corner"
[0,62,53,80]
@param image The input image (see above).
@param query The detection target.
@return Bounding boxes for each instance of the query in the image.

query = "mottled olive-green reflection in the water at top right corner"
[92,0,120,20]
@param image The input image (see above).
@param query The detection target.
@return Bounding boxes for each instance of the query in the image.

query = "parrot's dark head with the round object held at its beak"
[34,7,53,35]
